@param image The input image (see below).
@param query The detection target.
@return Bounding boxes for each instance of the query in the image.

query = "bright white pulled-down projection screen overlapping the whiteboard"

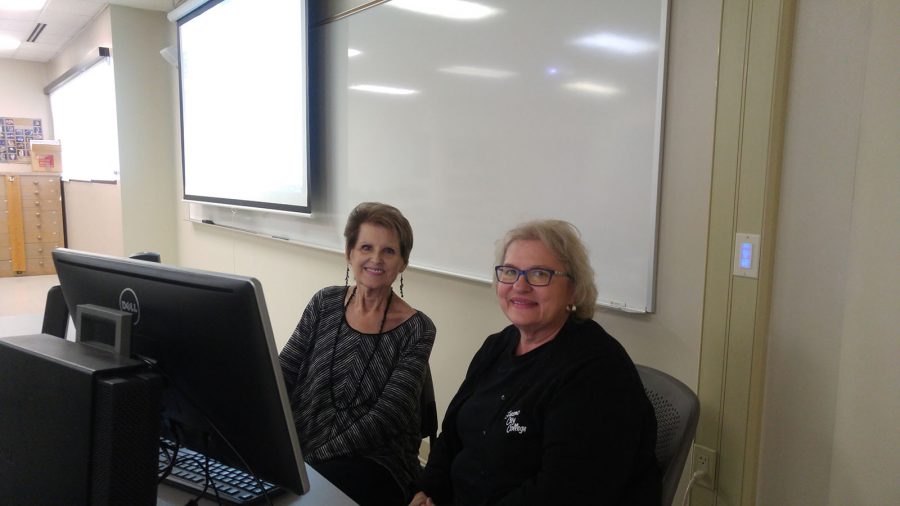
[173,0,310,213]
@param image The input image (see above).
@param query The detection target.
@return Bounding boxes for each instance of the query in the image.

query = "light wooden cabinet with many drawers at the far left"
[0,173,66,277]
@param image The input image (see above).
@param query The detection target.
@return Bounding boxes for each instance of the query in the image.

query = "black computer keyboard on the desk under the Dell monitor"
[159,440,282,505]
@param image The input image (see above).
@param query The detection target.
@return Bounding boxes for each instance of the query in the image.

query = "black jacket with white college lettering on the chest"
[419,320,661,506]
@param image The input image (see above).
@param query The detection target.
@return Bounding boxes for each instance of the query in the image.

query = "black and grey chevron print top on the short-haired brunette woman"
[279,286,435,490]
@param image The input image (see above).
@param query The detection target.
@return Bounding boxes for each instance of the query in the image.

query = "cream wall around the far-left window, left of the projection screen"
[42,5,178,263]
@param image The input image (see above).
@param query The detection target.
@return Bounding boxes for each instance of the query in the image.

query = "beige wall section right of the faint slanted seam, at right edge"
[828,0,900,506]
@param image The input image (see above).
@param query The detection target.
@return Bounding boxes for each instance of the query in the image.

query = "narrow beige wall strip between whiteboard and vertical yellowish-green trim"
[595,1,721,388]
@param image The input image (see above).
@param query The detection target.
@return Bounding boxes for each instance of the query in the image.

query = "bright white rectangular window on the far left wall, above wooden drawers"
[50,57,119,181]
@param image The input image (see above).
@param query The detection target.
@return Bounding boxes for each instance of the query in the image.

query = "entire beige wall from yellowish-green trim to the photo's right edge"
[757,0,900,505]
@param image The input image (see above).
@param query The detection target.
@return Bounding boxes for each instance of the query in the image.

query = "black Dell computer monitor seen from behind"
[53,248,309,494]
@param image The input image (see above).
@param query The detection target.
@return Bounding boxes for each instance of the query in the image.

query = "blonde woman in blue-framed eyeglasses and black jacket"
[410,220,660,506]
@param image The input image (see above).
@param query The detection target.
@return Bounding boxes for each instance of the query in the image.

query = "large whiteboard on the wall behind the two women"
[190,0,668,312]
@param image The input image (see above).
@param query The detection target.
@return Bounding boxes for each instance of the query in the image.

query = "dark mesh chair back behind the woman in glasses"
[636,365,700,506]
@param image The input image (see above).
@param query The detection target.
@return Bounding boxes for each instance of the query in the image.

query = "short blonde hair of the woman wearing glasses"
[494,220,597,320]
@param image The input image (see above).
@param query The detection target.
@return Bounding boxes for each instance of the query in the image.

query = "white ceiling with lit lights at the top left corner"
[0,0,180,62]
